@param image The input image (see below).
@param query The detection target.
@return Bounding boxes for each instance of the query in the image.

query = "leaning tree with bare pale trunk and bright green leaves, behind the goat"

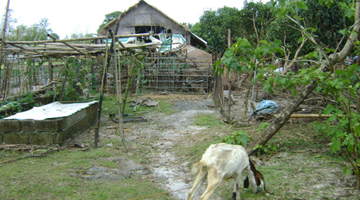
[217,0,360,189]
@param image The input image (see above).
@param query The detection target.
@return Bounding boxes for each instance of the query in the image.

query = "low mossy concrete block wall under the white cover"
[0,103,98,145]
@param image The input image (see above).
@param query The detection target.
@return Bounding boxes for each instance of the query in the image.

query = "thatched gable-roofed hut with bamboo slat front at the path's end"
[100,0,212,92]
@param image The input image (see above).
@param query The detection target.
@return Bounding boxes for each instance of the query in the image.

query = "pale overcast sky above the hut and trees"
[0,0,258,39]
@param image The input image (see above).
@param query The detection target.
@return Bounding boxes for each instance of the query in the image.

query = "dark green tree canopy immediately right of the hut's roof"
[191,2,275,53]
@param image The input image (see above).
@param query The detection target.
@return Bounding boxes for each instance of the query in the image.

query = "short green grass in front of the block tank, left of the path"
[0,145,167,199]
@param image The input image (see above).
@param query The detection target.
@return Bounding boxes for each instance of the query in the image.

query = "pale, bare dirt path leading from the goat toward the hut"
[134,100,215,199]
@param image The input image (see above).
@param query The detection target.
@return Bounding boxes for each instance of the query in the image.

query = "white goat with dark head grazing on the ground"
[187,143,266,200]
